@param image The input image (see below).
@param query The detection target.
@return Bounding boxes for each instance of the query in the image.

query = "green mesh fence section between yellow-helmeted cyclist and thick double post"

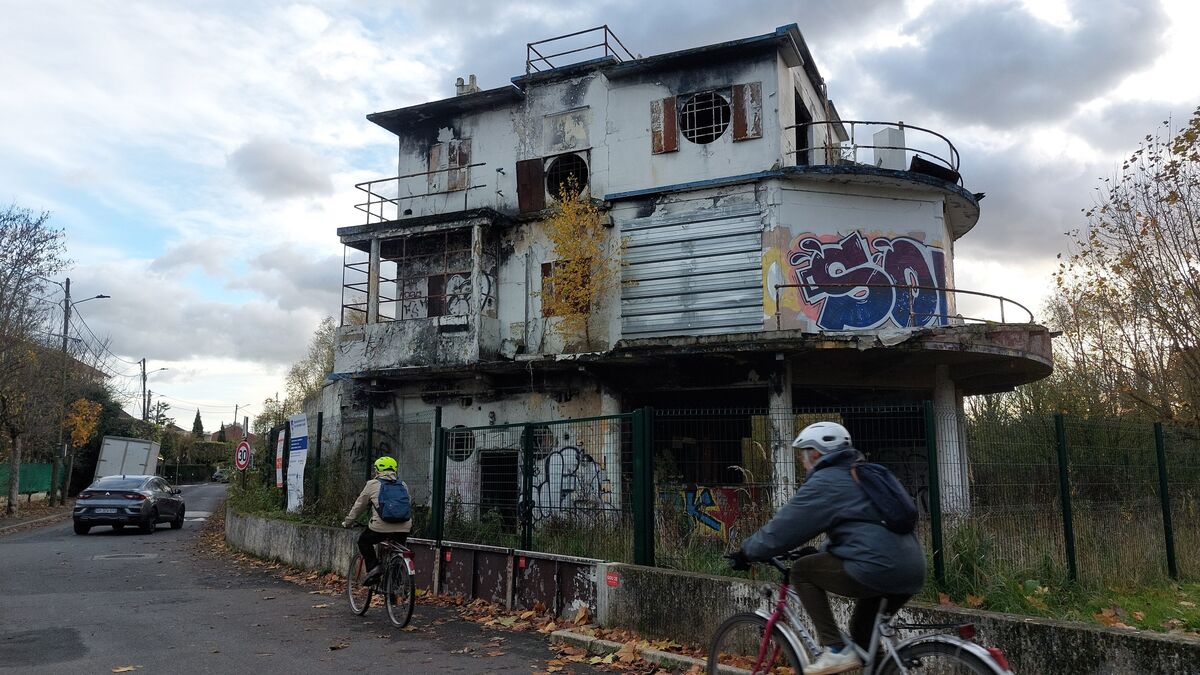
[433,411,653,563]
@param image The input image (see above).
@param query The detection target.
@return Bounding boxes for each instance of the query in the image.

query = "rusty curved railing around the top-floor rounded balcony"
[784,120,962,184]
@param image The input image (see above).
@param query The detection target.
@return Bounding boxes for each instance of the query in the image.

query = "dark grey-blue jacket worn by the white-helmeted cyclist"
[742,448,925,595]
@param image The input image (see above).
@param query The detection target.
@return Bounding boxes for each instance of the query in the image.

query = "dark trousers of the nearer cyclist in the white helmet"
[792,554,912,650]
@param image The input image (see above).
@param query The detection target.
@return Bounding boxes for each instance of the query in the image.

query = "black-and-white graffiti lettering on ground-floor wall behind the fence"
[534,446,612,521]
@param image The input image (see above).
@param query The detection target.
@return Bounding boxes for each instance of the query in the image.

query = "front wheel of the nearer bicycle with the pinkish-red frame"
[708,613,803,675]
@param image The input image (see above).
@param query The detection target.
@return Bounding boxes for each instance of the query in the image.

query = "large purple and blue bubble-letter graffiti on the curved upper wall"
[764,229,949,330]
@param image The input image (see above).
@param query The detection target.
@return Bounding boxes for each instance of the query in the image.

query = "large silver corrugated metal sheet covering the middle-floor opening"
[620,201,762,338]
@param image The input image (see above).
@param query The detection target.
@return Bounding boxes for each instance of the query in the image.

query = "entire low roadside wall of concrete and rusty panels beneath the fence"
[226,512,1200,675]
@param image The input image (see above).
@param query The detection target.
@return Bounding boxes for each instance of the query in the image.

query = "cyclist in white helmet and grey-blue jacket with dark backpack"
[726,422,925,675]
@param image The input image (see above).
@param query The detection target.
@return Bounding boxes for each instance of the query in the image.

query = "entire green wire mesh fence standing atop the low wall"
[415,402,1200,587]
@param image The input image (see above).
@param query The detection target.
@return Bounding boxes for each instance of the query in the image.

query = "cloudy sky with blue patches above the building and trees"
[0,0,1200,429]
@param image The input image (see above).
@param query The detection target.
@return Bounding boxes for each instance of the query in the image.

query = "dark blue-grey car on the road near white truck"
[73,476,186,534]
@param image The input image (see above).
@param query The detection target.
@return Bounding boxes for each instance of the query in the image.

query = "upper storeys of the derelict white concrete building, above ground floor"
[322,24,1051,509]
